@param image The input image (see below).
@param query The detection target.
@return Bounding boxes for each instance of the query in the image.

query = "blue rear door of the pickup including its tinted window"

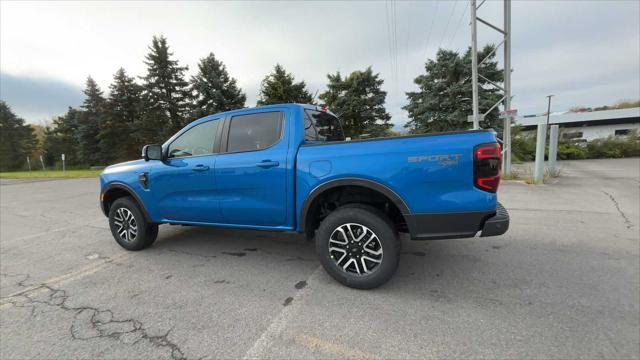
[215,109,288,227]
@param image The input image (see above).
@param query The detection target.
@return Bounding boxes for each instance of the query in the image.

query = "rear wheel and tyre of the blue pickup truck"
[316,205,400,289]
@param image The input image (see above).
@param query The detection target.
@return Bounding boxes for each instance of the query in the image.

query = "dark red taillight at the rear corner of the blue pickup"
[473,143,502,192]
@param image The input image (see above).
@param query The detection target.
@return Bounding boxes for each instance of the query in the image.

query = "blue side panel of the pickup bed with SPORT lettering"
[296,130,497,233]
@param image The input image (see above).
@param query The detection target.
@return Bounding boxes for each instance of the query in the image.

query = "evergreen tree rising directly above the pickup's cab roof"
[258,64,313,105]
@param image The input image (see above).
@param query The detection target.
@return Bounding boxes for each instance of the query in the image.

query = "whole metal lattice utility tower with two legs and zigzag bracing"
[469,0,515,175]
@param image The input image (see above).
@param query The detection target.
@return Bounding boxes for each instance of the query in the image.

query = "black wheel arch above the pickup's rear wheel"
[300,178,411,237]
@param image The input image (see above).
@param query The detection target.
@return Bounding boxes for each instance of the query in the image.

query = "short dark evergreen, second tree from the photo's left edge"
[43,107,83,166]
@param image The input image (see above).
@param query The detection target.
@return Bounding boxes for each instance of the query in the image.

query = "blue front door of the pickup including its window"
[149,119,222,223]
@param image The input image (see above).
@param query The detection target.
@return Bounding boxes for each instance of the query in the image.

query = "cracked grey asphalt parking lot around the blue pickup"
[0,158,640,359]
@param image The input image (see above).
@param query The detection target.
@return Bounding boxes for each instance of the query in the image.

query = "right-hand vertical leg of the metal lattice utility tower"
[502,0,512,175]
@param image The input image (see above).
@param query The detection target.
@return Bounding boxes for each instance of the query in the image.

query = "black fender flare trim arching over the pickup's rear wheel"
[300,178,411,232]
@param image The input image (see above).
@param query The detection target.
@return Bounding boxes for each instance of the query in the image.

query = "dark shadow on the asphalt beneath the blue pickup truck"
[149,225,503,301]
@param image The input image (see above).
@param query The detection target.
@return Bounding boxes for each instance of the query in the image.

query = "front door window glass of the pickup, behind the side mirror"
[168,120,220,158]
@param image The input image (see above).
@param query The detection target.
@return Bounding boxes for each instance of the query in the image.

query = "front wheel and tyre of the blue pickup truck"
[109,197,158,250]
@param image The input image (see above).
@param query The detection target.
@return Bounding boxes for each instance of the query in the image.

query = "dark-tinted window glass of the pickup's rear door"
[227,112,282,152]
